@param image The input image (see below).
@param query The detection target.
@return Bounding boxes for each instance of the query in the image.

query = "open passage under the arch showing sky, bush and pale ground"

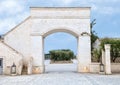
[44,32,77,72]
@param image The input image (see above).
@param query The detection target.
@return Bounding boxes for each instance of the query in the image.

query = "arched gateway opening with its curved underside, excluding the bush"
[44,29,78,72]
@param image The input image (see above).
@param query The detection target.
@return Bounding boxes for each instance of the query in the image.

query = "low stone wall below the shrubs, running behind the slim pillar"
[90,63,120,73]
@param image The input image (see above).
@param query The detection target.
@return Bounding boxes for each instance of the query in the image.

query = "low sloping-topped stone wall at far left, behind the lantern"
[0,41,23,74]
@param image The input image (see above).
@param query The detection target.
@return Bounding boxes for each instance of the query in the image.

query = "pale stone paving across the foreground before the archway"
[0,72,120,85]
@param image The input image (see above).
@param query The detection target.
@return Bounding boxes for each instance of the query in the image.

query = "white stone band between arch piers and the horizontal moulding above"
[31,18,90,37]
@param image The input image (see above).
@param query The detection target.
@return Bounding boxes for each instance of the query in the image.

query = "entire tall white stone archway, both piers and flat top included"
[31,8,91,73]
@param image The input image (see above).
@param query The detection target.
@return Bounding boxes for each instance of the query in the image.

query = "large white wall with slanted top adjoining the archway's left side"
[4,17,31,57]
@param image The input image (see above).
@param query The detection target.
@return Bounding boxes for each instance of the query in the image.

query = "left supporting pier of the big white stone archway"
[31,35,44,74]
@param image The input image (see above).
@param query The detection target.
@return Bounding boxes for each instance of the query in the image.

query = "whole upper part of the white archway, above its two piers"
[31,7,90,37]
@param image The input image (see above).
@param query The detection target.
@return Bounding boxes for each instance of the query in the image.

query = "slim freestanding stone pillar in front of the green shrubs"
[105,44,111,74]
